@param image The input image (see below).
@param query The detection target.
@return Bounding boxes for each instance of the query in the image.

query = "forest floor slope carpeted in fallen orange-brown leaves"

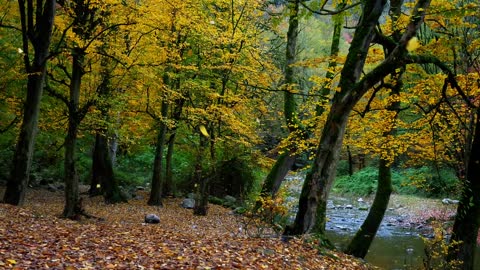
[0,190,376,269]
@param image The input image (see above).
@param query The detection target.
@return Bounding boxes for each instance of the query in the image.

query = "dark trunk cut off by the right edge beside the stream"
[448,109,480,270]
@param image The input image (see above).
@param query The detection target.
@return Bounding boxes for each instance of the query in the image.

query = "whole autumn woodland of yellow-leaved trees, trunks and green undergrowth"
[0,0,480,269]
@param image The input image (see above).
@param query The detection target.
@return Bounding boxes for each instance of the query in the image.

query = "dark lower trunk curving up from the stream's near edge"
[345,159,393,258]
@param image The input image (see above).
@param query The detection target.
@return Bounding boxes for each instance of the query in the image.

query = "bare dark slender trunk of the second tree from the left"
[63,48,85,219]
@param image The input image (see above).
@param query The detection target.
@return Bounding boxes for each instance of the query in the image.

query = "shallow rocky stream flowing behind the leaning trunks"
[289,176,480,269]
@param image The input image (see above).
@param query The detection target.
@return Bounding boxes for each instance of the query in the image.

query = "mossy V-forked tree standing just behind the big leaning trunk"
[261,1,346,197]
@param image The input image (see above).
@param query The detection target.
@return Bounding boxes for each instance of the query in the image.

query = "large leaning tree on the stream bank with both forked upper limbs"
[285,0,430,235]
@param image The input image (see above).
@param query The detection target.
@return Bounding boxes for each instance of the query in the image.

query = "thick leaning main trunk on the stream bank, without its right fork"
[285,0,386,235]
